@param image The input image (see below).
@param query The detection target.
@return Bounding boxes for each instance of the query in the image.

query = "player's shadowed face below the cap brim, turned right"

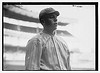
[45,14,57,30]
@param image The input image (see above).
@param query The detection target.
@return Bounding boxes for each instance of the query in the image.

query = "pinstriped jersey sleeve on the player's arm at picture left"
[25,39,42,70]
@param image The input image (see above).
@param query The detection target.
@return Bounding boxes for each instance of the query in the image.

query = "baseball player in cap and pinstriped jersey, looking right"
[25,7,71,70]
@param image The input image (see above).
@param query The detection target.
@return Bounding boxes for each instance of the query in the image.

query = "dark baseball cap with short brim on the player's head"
[39,7,60,18]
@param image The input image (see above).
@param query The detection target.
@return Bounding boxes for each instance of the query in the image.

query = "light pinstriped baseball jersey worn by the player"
[25,32,71,70]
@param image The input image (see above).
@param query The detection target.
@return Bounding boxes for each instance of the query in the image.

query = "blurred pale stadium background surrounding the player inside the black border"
[2,4,95,70]
